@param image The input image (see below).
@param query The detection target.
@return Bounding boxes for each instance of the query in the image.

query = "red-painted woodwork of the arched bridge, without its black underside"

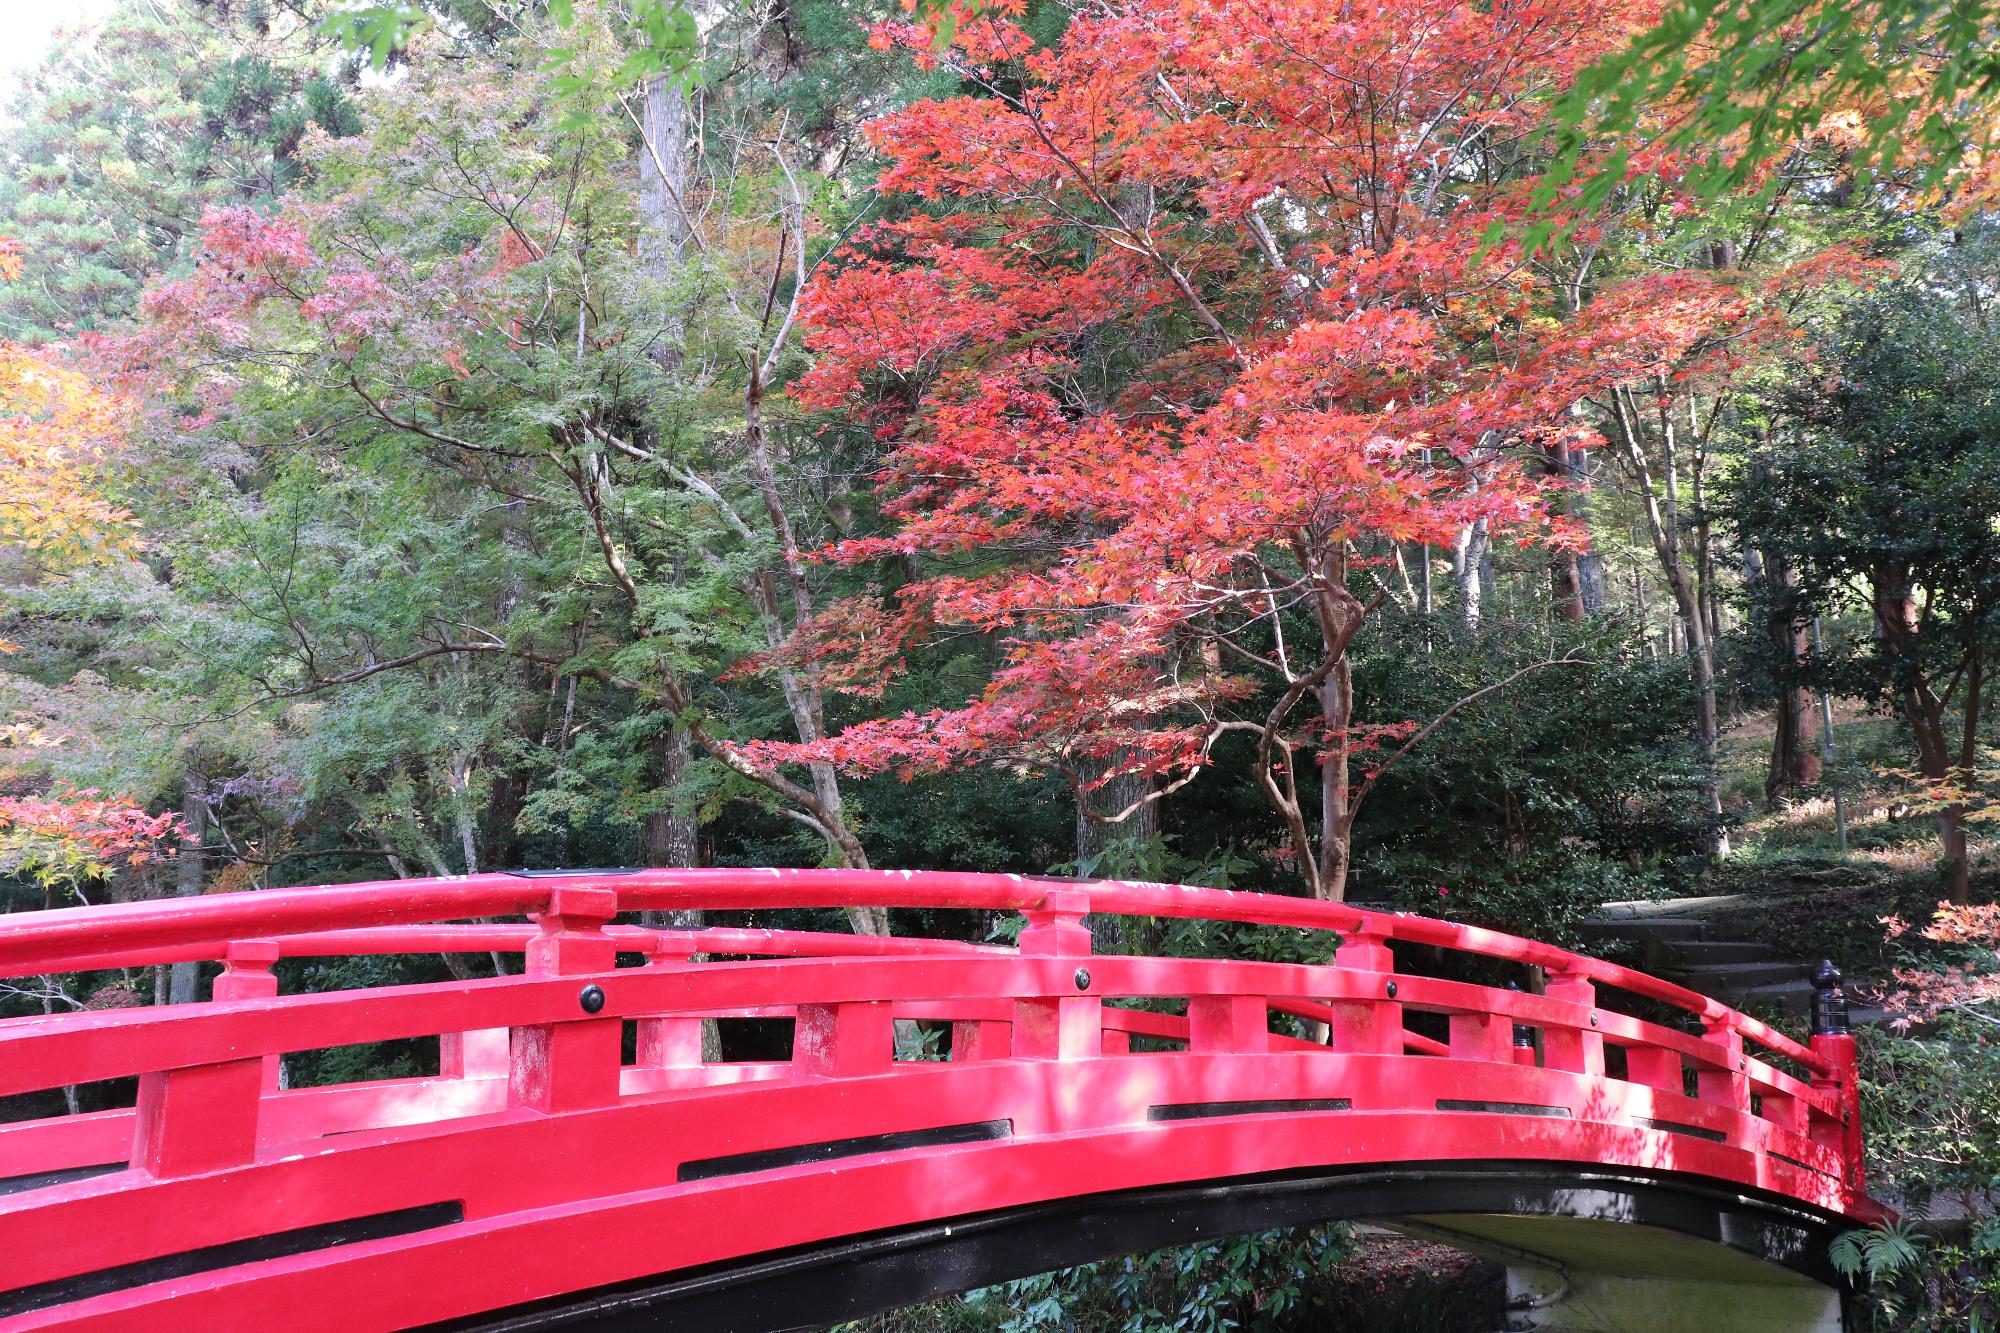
[0,871,1882,1333]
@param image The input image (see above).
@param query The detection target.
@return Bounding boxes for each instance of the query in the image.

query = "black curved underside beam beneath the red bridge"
[432,1161,1844,1333]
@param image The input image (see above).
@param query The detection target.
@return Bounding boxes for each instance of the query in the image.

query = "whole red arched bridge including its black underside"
[0,871,1882,1333]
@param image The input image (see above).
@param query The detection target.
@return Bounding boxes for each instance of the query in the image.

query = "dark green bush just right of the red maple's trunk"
[1350,616,1710,939]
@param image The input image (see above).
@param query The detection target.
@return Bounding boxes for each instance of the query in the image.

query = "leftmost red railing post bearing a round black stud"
[508,885,622,1111]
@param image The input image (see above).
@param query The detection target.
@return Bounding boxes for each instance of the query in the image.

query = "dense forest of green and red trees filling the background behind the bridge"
[0,0,2000,1327]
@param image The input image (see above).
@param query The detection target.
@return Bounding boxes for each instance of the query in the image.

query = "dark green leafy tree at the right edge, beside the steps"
[1724,274,2000,888]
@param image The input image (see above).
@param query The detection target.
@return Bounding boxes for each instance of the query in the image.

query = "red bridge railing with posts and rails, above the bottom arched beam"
[0,871,1874,1241]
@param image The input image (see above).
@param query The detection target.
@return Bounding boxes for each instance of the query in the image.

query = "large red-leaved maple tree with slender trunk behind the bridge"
[750,0,1816,899]
